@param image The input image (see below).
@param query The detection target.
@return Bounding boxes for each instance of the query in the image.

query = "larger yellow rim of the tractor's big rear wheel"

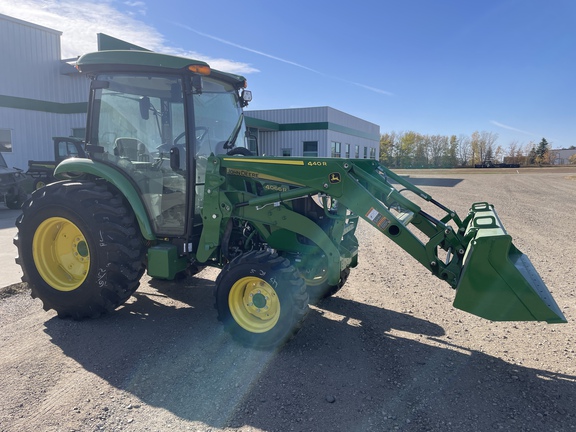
[32,217,90,291]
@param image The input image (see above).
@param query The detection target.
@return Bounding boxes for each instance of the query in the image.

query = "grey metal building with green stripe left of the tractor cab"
[0,14,89,169]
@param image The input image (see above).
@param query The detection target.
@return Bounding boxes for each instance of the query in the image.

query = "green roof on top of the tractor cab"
[76,50,246,86]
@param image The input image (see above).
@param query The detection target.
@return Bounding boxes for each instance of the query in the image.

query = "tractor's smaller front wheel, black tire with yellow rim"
[215,251,308,349]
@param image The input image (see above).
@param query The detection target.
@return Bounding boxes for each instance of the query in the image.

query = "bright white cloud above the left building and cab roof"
[0,0,257,75]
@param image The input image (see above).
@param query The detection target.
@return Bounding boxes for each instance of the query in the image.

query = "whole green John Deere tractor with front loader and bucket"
[14,51,566,349]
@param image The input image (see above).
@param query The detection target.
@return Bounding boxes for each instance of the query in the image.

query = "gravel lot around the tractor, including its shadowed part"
[0,169,576,432]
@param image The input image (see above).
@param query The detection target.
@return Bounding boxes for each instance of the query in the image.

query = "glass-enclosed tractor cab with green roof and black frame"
[78,51,248,236]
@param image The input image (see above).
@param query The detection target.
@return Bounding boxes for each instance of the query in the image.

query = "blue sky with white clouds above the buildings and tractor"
[0,0,576,148]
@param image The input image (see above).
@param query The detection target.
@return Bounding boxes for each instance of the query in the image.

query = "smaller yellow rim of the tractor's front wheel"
[228,276,280,333]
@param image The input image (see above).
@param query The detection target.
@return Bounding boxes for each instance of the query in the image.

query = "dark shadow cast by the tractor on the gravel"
[45,273,576,431]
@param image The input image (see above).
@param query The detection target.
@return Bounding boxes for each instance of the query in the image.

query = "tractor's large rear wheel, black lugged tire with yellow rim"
[14,182,145,319]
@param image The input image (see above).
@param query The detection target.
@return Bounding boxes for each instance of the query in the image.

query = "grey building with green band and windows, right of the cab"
[246,107,380,159]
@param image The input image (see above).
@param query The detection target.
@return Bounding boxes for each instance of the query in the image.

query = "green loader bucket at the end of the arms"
[454,203,566,323]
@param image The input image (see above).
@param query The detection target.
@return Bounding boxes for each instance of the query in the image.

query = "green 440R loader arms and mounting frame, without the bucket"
[199,157,466,287]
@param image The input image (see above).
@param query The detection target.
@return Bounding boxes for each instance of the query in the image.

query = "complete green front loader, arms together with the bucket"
[204,156,566,323]
